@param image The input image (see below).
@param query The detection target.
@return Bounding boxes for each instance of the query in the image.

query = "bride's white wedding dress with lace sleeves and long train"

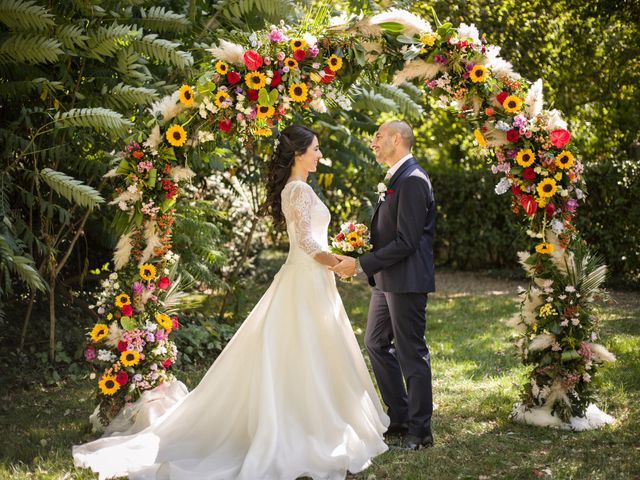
[73,181,389,480]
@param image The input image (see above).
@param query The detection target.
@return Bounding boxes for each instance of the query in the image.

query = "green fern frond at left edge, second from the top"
[0,34,64,64]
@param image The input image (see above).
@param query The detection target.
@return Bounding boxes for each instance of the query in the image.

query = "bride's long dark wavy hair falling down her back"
[265,124,318,227]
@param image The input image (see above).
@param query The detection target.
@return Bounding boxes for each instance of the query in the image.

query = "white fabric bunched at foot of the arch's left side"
[89,380,189,437]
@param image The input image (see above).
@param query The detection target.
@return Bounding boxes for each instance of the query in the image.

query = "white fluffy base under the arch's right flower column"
[509,403,615,432]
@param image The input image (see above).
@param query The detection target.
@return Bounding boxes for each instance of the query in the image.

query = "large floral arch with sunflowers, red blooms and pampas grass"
[85,6,615,429]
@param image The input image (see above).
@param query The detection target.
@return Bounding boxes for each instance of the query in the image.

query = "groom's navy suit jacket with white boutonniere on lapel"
[360,158,436,293]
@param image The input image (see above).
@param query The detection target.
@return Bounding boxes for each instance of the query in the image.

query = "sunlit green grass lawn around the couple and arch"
[0,260,640,480]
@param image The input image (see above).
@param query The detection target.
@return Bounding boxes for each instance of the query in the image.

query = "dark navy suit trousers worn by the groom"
[365,288,433,437]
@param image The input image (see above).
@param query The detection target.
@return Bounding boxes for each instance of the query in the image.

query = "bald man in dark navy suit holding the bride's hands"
[332,120,436,450]
